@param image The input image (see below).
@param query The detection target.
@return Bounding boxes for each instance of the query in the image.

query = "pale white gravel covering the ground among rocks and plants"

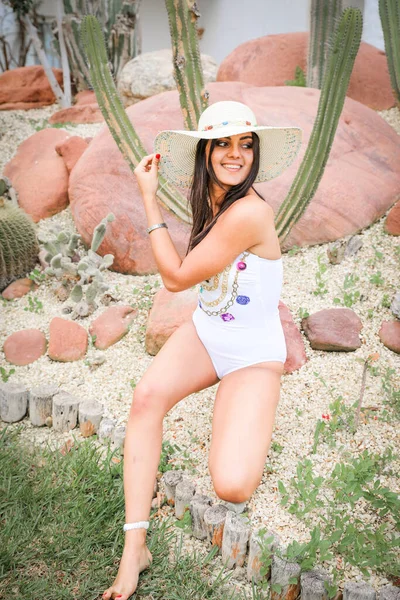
[0,105,400,589]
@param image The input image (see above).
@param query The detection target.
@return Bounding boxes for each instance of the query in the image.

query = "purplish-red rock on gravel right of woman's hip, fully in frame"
[301,308,362,352]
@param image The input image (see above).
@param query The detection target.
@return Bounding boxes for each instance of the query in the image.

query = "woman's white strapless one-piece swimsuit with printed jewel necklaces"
[192,251,287,379]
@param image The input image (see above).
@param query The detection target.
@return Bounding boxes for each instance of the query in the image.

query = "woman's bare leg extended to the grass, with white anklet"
[103,321,219,600]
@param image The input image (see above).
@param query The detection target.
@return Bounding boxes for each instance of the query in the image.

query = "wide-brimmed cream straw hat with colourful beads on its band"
[154,100,302,187]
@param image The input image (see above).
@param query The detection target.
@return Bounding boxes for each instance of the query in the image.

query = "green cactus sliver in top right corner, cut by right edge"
[379,0,400,104]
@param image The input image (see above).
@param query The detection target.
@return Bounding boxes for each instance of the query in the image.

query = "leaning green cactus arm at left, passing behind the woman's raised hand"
[81,15,192,223]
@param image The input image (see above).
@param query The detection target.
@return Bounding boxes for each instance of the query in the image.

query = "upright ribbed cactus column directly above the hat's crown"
[165,0,209,130]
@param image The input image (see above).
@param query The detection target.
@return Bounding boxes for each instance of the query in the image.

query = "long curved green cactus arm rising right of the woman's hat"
[275,8,363,242]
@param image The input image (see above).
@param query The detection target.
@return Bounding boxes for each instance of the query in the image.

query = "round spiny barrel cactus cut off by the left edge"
[0,196,39,292]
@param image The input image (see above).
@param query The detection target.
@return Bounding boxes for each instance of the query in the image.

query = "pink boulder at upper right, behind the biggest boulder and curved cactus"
[217,32,396,110]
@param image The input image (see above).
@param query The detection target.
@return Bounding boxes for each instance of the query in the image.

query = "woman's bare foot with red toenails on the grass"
[102,546,153,600]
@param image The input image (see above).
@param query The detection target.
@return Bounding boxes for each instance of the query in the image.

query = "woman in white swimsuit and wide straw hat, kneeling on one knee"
[103,102,301,600]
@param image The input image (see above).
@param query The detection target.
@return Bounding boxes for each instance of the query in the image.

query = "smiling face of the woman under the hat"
[207,133,254,189]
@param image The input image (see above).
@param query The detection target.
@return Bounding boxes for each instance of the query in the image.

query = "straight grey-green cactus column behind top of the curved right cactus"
[307,0,342,90]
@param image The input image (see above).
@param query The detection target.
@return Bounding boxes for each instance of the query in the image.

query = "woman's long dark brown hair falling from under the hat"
[186,132,265,255]
